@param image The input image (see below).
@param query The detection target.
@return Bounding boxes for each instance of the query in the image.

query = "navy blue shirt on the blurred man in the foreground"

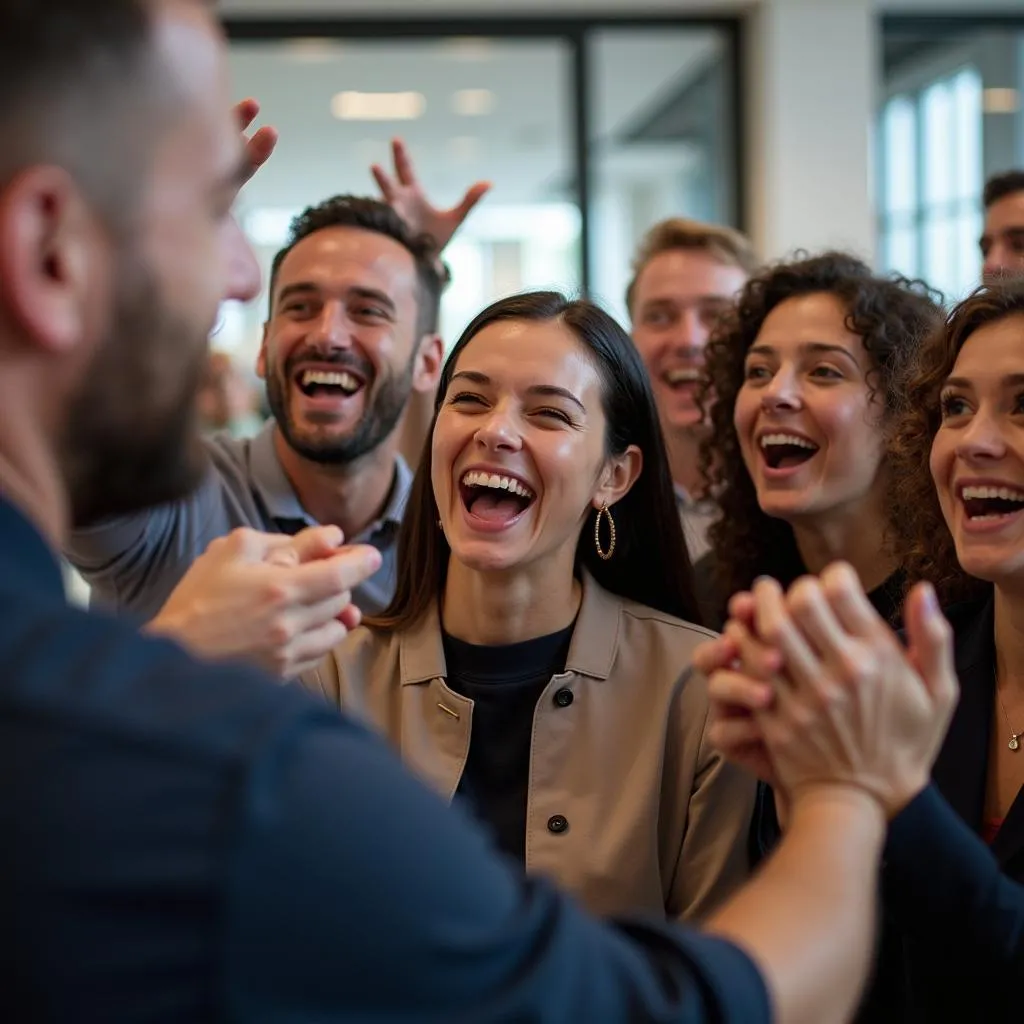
[0,493,769,1024]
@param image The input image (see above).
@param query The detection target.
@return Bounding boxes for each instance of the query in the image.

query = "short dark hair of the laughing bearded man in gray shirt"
[268,195,442,337]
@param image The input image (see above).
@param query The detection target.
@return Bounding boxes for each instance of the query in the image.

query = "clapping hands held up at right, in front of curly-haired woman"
[695,563,958,824]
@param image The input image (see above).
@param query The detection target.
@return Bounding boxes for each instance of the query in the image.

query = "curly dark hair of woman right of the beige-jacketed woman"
[700,252,941,613]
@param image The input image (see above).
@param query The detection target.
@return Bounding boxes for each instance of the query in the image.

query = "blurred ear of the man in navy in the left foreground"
[0,166,104,352]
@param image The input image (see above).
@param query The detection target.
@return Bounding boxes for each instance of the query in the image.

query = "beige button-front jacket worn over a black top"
[303,577,755,919]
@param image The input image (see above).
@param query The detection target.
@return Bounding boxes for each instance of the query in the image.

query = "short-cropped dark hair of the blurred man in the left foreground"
[0,0,165,228]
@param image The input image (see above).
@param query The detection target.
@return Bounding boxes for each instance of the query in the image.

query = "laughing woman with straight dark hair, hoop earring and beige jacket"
[306,292,754,918]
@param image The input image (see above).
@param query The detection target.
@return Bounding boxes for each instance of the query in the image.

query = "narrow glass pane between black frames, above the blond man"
[587,28,736,323]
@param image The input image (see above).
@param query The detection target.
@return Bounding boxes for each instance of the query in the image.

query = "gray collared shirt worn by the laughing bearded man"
[66,420,413,621]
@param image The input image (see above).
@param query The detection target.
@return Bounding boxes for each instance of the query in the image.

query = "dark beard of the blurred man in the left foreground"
[60,256,208,527]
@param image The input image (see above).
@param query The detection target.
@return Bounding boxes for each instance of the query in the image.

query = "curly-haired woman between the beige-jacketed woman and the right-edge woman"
[697,253,941,627]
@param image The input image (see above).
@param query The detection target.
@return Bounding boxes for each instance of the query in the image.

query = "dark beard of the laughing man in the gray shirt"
[266,348,416,466]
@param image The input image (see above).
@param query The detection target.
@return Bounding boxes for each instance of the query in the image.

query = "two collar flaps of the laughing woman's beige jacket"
[398,570,623,686]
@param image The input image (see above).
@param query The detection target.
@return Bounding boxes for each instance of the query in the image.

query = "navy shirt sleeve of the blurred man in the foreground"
[223,722,770,1024]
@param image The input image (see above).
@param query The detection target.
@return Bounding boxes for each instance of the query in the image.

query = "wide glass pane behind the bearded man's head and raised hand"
[231,37,581,351]
